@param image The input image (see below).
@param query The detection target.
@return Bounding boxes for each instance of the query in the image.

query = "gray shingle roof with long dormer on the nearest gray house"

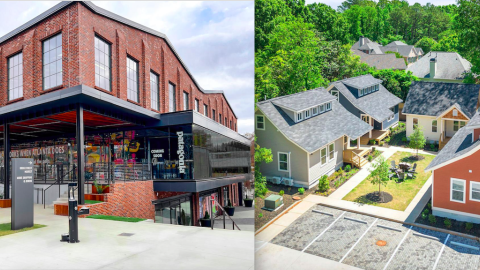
[257,89,372,153]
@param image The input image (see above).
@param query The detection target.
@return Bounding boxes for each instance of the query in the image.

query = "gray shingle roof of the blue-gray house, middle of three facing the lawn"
[333,74,402,122]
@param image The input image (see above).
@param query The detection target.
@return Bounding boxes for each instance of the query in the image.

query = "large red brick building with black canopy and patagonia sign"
[0,2,250,225]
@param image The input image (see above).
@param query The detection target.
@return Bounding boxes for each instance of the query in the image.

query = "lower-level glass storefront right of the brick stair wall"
[155,194,193,226]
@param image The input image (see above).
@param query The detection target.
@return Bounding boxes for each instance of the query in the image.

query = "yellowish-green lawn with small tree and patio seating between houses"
[343,152,435,211]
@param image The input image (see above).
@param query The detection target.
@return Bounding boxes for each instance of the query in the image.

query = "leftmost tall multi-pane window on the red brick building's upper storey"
[8,53,23,100]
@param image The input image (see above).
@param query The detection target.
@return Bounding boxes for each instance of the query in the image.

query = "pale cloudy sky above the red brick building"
[0,1,254,134]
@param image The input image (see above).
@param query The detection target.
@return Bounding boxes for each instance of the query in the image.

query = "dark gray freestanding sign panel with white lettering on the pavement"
[12,158,33,230]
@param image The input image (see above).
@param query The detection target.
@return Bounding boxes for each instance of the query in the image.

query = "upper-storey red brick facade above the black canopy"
[0,2,238,131]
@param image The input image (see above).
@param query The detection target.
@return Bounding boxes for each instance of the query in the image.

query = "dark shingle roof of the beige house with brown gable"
[403,81,480,118]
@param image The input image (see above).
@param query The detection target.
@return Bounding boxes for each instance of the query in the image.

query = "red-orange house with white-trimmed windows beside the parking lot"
[426,112,480,223]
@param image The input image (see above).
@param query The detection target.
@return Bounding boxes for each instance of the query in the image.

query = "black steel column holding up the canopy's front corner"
[75,104,85,205]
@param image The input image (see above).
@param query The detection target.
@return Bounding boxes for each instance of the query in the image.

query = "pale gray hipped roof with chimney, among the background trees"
[407,52,472,80]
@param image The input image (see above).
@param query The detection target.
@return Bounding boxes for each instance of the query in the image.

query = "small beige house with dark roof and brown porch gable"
[403,81,480,149]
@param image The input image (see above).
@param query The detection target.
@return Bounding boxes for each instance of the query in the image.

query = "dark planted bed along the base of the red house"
[415,201,480,237]
